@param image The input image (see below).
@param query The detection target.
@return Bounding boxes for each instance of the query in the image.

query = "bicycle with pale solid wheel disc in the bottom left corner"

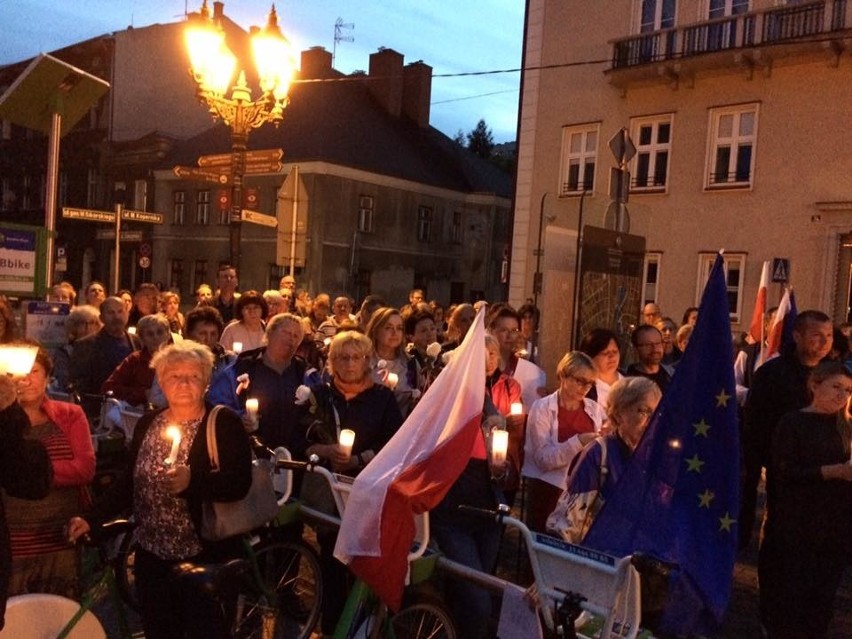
[3,519,134,639]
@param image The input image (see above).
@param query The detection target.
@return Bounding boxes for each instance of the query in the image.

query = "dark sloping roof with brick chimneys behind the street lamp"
[163,77,512,198]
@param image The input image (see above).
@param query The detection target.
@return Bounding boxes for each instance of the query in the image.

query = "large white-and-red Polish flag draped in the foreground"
[334,307,485,610]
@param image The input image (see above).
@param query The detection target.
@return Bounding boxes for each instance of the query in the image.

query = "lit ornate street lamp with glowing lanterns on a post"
[185,0,296,269]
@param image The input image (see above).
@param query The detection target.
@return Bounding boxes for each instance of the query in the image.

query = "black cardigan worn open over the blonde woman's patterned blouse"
[85,404,251,561]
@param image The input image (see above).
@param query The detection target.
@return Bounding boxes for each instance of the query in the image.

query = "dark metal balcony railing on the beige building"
[612,0,852,69]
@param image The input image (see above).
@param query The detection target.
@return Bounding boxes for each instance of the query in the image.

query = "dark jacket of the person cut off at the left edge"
[0,403,53,630]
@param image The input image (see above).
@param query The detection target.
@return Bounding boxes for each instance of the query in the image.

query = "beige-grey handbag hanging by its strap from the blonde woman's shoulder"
[201,406,278,541]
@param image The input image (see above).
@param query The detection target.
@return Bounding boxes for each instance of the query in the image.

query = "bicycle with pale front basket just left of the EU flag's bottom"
[437,506,677,639]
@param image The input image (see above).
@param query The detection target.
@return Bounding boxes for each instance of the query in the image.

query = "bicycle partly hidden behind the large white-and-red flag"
[279,457,457,639]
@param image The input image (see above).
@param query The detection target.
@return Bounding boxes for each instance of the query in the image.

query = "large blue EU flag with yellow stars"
[583,254,739,635]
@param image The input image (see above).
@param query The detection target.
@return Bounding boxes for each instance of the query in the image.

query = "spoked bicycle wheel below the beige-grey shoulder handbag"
[233,542,322,639]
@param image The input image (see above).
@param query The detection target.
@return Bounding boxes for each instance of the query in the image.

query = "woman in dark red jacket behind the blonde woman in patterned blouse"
[101,315,171,406]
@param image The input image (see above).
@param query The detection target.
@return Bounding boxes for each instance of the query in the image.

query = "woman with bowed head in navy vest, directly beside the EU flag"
[547,377,662,544]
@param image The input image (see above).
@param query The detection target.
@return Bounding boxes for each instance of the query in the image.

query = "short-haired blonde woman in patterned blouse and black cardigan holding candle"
[68,340,251,639]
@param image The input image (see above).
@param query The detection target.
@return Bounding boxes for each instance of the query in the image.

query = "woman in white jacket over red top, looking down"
[521,351,606,532]
